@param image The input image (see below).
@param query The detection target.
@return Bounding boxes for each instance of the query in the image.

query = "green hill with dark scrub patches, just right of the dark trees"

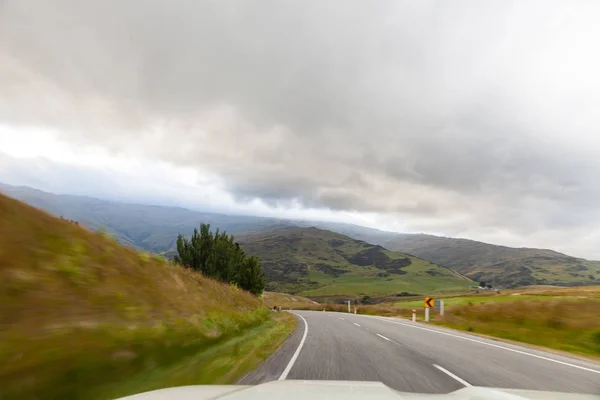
[238,227,473,297]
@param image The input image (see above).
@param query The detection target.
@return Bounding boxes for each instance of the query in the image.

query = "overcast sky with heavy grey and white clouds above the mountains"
[0,0,600,259]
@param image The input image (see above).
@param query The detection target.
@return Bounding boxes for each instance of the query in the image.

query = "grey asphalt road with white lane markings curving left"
[239,311,600,398]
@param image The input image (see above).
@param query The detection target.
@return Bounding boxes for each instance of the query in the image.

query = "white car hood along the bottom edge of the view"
[121,380,600,400]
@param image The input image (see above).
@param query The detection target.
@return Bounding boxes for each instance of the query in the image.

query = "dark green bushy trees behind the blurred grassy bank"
[174,224,265,296]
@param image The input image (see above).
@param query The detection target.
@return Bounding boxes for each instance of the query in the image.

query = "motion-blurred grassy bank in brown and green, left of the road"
[0,195,295,399]
